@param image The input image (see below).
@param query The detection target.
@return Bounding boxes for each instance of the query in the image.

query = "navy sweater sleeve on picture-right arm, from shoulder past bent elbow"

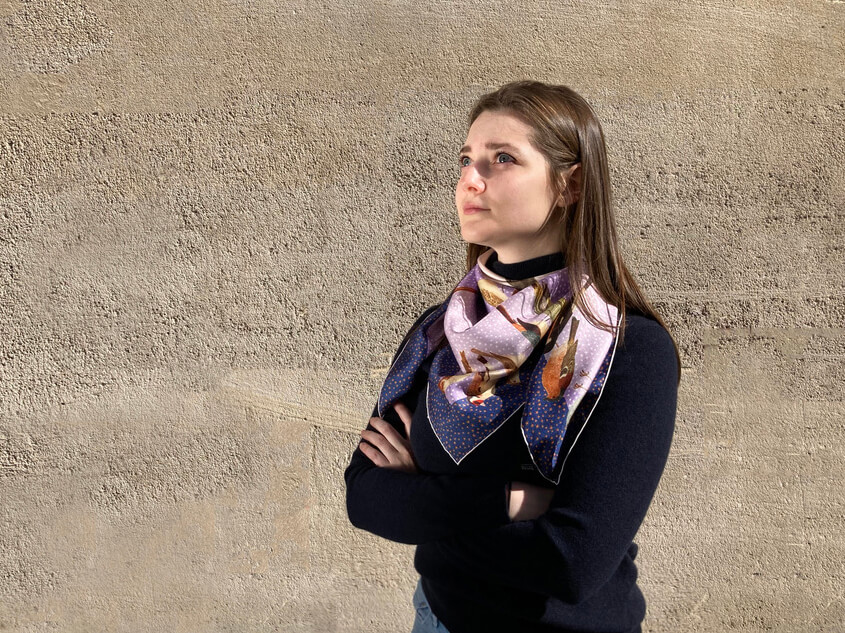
[417,319,678,604]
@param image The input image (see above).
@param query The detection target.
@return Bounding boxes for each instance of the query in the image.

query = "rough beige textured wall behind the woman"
[0,0,845,633]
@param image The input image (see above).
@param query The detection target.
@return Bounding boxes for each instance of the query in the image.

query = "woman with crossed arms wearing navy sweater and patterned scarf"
[346,82,680,633]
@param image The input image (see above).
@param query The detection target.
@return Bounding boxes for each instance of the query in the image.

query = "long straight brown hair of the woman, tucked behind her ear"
[467,81,681,377]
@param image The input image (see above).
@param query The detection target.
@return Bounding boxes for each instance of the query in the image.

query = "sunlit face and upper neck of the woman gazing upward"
[455,110,560,263]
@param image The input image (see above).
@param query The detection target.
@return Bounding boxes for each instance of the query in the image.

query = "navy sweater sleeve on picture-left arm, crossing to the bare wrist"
[344,306,509,544]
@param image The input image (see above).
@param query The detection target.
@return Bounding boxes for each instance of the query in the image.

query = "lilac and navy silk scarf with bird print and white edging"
[378,250,618,484]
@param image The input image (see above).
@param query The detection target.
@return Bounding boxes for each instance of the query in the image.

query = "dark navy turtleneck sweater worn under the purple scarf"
[345,254,678,633]
